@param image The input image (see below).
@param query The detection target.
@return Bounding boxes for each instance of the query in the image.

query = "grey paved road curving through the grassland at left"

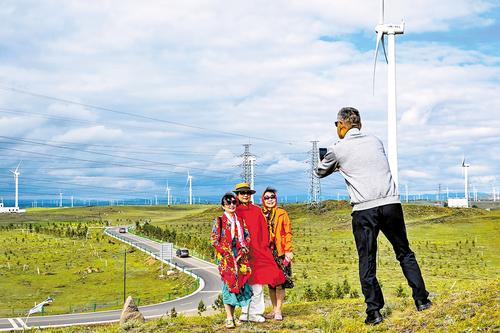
[0,227,221,331]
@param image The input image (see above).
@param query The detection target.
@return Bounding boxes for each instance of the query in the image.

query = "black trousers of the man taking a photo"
[352,203,429,313]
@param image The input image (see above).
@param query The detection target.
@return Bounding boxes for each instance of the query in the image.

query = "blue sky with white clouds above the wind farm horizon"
[0,0,500,201]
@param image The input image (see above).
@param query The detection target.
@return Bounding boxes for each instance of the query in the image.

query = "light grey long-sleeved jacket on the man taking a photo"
[316,128,401,211]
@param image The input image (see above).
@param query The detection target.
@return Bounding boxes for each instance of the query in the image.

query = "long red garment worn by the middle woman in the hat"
[236,203,285,287]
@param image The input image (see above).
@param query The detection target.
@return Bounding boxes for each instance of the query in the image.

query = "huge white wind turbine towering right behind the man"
[373,0,405,187]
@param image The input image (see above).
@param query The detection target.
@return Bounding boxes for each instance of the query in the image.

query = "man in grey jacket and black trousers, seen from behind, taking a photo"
[316,107,432,325]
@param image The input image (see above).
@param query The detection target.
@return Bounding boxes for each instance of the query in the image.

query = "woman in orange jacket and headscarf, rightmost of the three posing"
[262,187,293,320]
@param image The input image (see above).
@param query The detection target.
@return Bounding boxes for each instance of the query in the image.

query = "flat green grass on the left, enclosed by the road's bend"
[0,229,197,317]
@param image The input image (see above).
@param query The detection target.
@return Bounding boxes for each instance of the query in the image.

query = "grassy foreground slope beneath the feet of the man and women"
[44,280,500,333]
